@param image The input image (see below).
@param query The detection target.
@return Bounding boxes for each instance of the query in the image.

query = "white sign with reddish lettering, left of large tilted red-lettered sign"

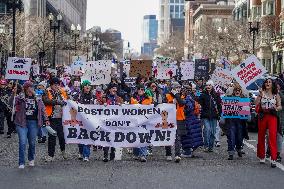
[211,67,234,94]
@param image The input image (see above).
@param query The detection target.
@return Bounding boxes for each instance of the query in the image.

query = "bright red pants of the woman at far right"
[257,114,277,160]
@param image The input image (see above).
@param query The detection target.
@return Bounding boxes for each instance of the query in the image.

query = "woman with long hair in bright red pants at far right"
[255,78,282,168]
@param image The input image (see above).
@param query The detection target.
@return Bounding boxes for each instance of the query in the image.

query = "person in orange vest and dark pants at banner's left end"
[42,77,68,162]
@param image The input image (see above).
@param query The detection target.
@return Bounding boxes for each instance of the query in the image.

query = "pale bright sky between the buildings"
[87,0,159,52]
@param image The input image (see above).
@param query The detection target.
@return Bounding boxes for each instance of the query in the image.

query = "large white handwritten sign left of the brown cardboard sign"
[81,60,112,85]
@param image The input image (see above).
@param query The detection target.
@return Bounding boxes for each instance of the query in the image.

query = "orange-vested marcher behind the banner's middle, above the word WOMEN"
[130,84,153,162]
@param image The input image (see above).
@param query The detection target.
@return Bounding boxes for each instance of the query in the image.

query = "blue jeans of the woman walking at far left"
[17,120,38,165]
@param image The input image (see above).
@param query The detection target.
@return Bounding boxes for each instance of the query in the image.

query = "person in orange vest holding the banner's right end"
[165,82,186,163]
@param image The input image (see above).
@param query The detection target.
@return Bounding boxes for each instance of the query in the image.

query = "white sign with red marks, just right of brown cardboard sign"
[156,59,178,79]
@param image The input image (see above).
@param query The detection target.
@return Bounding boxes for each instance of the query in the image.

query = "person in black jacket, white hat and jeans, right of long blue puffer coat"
[199,80,222,152]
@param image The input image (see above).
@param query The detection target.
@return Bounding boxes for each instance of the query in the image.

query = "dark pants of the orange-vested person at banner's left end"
[48,119,65,157]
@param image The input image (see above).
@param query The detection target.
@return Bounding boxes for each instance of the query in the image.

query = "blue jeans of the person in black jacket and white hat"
[203,119,217,150]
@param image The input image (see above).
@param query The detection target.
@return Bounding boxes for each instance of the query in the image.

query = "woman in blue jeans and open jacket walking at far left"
[10,81,49,169]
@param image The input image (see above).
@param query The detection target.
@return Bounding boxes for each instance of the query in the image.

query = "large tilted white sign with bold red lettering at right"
[231,55,267,89]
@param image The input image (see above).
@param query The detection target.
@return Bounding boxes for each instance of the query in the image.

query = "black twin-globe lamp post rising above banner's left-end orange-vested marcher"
[48,13,62,69]
